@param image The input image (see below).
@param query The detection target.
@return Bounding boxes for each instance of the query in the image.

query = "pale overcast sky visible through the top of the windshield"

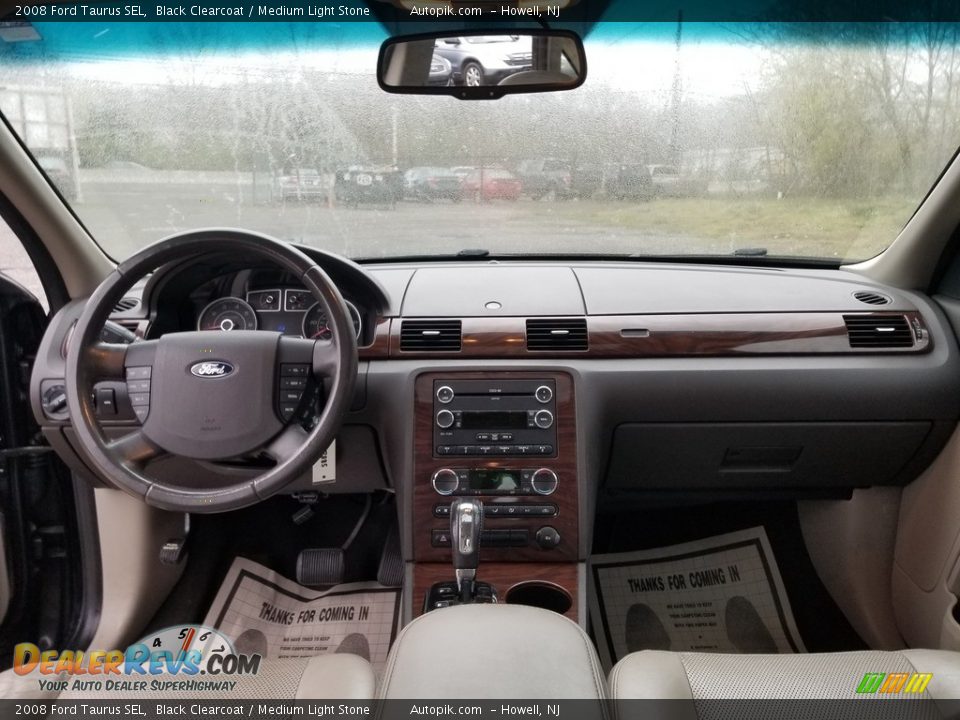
[0,22,763,100]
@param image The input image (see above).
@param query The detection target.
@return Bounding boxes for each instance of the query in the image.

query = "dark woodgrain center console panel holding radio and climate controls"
[412,372,579,617]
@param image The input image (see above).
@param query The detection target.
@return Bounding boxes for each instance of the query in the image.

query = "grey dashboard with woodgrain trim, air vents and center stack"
[31,242,960,613]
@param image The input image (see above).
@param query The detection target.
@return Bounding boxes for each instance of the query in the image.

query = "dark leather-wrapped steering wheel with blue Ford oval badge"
[65,229,357,513]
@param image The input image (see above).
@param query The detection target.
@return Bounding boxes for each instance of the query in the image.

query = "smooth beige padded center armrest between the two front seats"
[380,605,606,700]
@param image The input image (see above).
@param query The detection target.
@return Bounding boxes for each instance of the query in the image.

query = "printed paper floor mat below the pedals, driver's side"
[204,558,400,672]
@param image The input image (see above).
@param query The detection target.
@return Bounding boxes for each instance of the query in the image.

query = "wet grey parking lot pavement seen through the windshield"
[74,182,696,259]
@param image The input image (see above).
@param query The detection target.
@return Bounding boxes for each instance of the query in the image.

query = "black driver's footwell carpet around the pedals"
[144,493,396,633]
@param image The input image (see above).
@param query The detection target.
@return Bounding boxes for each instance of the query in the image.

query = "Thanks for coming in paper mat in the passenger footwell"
[589,527,803,667]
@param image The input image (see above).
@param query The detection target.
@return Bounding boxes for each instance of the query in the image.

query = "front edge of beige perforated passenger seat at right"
[610,650,960,700]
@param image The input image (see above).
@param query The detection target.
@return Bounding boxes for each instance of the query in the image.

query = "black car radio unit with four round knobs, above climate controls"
[433,380,557,457]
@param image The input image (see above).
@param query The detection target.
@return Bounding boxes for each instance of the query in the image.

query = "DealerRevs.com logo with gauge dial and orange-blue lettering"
[13,625,262,692]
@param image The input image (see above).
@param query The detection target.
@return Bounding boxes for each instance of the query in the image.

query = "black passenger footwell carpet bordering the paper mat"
[593,502,867,652]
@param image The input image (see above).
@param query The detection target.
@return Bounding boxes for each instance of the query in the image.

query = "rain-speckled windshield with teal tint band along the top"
[0,22,960,262]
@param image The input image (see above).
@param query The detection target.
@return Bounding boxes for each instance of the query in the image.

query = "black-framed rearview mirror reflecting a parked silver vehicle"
[377,30,587,100]
